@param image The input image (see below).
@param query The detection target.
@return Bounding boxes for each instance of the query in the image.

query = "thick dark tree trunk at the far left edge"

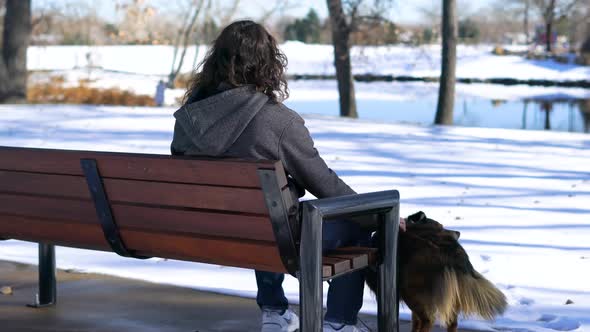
[0,0,31,103]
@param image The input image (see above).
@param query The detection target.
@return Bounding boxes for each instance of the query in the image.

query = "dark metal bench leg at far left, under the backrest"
[28,243,57,308]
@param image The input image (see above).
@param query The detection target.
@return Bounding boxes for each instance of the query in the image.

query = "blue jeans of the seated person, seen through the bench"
[256,220,371,325]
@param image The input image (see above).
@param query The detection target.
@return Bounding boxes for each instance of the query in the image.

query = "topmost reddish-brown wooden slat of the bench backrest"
[0,147,287,188]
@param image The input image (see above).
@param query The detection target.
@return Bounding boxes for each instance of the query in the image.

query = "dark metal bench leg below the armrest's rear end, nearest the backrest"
[299,203,323,332]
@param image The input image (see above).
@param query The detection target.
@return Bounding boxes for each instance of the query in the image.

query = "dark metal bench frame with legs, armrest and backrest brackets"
[1,148,399,332]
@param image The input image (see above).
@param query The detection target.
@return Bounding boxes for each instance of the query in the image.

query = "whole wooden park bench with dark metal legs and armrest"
[0,147,399,332]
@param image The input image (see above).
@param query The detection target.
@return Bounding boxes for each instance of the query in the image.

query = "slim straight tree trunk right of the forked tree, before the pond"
[434,0,457,125]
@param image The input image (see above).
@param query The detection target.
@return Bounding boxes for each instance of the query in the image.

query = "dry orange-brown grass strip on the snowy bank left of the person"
[27,76,156,106]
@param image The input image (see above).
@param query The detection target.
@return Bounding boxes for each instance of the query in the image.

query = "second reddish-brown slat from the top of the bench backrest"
[0,171,268,215]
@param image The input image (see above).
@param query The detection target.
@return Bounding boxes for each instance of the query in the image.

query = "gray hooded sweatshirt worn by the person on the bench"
[171,85,355,201]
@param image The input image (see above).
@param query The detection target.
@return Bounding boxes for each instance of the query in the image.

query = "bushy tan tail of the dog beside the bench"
[450,270,508,320]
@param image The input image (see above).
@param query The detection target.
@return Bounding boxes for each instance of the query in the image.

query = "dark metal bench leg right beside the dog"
[377,208,399,332]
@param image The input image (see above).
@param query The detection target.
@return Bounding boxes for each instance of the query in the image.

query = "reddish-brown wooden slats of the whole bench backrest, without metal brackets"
[0,147,296,272]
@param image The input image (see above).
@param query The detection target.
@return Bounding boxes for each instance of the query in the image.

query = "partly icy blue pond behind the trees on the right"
[285,81,590,133]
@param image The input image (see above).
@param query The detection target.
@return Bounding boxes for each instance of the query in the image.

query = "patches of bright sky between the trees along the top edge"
[33,0,493,23]
